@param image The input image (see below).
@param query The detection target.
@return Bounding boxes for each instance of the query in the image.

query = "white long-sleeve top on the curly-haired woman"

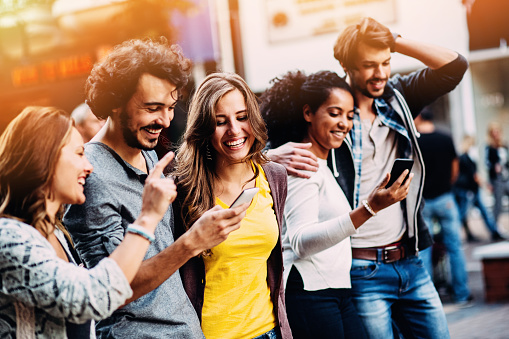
[282,159,356,291]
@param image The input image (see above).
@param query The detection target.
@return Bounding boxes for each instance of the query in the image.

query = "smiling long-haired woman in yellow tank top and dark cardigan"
[175,73,291,339]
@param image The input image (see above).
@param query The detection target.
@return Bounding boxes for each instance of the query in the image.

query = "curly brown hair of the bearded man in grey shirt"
[85,37,191,119]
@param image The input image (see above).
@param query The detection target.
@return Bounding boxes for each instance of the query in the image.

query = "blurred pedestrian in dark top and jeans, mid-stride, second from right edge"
[453,135,503,241]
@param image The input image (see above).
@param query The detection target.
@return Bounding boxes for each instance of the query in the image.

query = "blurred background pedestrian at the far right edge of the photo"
[485,121,509,228]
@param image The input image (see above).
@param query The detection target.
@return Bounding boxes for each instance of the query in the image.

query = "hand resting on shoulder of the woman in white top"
[267,142,318,178]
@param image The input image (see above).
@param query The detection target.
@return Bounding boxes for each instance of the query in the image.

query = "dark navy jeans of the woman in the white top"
[285,266,367,339]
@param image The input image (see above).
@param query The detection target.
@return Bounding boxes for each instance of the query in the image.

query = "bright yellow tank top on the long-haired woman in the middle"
[202,166,279,339]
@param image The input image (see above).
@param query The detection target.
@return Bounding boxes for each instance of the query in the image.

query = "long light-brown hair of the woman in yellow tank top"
[174,73,267,229]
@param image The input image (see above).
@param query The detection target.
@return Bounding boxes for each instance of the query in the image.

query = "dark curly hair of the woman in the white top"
[260,71,355,148]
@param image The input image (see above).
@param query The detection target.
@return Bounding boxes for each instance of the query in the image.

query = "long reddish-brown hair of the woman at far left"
[0,106,73,237]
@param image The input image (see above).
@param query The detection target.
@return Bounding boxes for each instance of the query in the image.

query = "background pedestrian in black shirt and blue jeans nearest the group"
[415,106,472,306]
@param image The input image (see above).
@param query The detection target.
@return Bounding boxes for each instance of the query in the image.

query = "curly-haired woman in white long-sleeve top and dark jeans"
[261,71,412,339]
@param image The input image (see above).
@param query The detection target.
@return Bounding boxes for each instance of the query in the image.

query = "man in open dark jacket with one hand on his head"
[268,18,468,338]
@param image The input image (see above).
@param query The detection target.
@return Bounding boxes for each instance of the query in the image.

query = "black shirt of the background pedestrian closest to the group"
[418,131,457,199]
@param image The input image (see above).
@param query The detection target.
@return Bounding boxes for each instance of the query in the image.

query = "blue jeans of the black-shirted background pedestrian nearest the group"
[421,193,470,301]
